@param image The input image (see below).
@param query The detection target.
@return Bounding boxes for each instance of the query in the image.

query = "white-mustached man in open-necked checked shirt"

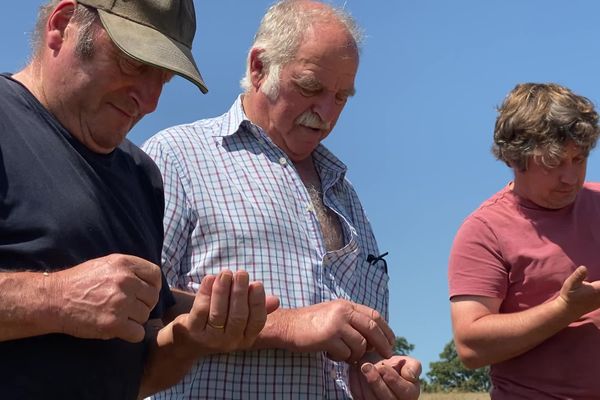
[143,0,421,399]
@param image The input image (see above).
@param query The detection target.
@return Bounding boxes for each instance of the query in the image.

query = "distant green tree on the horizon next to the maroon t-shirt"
[422,340,491,392]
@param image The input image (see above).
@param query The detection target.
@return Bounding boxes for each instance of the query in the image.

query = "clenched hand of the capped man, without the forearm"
[46,254,161,342]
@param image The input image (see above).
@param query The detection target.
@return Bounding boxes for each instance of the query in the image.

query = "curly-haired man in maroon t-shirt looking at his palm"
[449,83,600,400]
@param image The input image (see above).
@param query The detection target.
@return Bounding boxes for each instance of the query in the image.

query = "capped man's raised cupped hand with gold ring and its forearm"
[139,271,279,398]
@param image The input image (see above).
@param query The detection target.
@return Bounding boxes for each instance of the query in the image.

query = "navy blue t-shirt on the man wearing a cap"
[0,75,173,400]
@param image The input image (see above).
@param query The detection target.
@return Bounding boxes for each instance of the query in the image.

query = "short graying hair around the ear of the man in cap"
[31,0,100,58]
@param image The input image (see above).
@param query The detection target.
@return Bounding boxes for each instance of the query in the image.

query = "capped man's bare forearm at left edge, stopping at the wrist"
[0,272,60,341]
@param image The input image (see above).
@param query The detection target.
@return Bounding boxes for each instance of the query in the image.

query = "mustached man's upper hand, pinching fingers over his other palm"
[256,300,395,362]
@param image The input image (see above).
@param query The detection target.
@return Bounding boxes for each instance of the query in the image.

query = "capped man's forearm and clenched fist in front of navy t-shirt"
[0,254,160,342]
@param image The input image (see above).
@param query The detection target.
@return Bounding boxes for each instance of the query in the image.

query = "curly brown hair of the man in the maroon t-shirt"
[492,83,600,171]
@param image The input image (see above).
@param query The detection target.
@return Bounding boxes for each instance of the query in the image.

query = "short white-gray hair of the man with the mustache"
[240,0,363,99]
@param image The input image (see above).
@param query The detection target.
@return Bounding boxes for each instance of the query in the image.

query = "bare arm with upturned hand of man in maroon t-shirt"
[450,267,600,368]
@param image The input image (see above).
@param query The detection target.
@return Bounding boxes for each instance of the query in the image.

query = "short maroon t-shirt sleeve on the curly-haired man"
[448,215,508,299]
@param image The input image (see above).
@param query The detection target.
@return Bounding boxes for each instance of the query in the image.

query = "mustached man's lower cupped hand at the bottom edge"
[350,356,421,400]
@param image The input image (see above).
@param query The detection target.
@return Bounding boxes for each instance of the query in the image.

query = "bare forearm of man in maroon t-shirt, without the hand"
[452,298,578,368]
